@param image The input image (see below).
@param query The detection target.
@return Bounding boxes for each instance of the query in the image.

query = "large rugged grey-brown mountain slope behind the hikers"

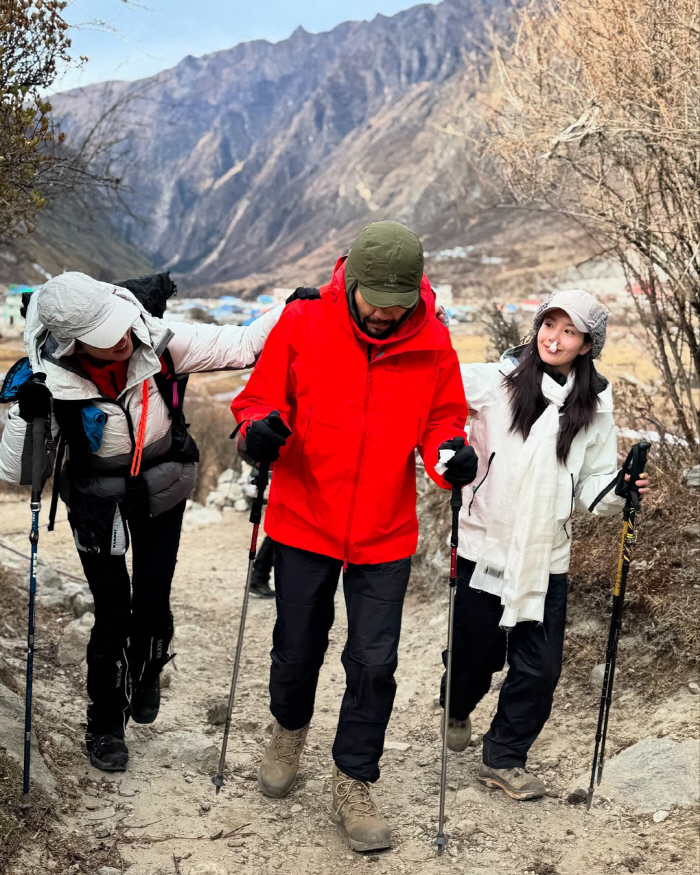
[52,0,506,289]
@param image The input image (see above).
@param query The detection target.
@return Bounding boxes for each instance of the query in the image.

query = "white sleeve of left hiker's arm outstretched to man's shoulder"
[168,305,284,374]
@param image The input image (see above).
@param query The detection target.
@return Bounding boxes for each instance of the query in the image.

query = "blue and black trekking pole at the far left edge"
[19,408,46,817]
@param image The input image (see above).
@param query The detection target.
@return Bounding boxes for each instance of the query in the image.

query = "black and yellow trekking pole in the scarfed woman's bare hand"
[586,441,651,810]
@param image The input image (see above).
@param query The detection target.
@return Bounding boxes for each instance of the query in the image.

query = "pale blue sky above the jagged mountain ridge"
[55,0,418,91]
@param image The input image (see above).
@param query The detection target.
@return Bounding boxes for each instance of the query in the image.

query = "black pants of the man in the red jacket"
[270,543,411,781]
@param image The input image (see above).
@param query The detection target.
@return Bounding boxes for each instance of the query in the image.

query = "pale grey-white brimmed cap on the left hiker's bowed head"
[36,271,141,358]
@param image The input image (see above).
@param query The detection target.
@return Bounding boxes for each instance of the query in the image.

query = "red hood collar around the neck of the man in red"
[326,256,450,349]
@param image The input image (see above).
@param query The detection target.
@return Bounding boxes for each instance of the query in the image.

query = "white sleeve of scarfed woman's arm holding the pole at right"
[575,412,625,516]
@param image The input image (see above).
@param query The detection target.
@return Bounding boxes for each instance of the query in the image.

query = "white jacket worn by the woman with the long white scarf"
[458,353,624,574]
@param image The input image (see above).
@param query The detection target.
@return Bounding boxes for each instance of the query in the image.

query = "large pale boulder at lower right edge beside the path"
[572,737,700,814]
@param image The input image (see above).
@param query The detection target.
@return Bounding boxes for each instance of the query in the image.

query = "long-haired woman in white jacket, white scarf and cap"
[442,290,648,799]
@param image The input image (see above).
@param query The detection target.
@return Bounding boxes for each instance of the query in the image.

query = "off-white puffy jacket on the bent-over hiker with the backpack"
[0,286,282,516]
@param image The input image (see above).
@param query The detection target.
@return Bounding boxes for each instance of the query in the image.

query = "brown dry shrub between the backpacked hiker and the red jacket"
[185,396,239,501]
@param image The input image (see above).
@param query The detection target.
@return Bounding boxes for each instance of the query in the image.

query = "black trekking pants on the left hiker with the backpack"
[72,500,185,735]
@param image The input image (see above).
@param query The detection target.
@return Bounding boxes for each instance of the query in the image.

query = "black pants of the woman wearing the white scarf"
[441,557,567,769]
